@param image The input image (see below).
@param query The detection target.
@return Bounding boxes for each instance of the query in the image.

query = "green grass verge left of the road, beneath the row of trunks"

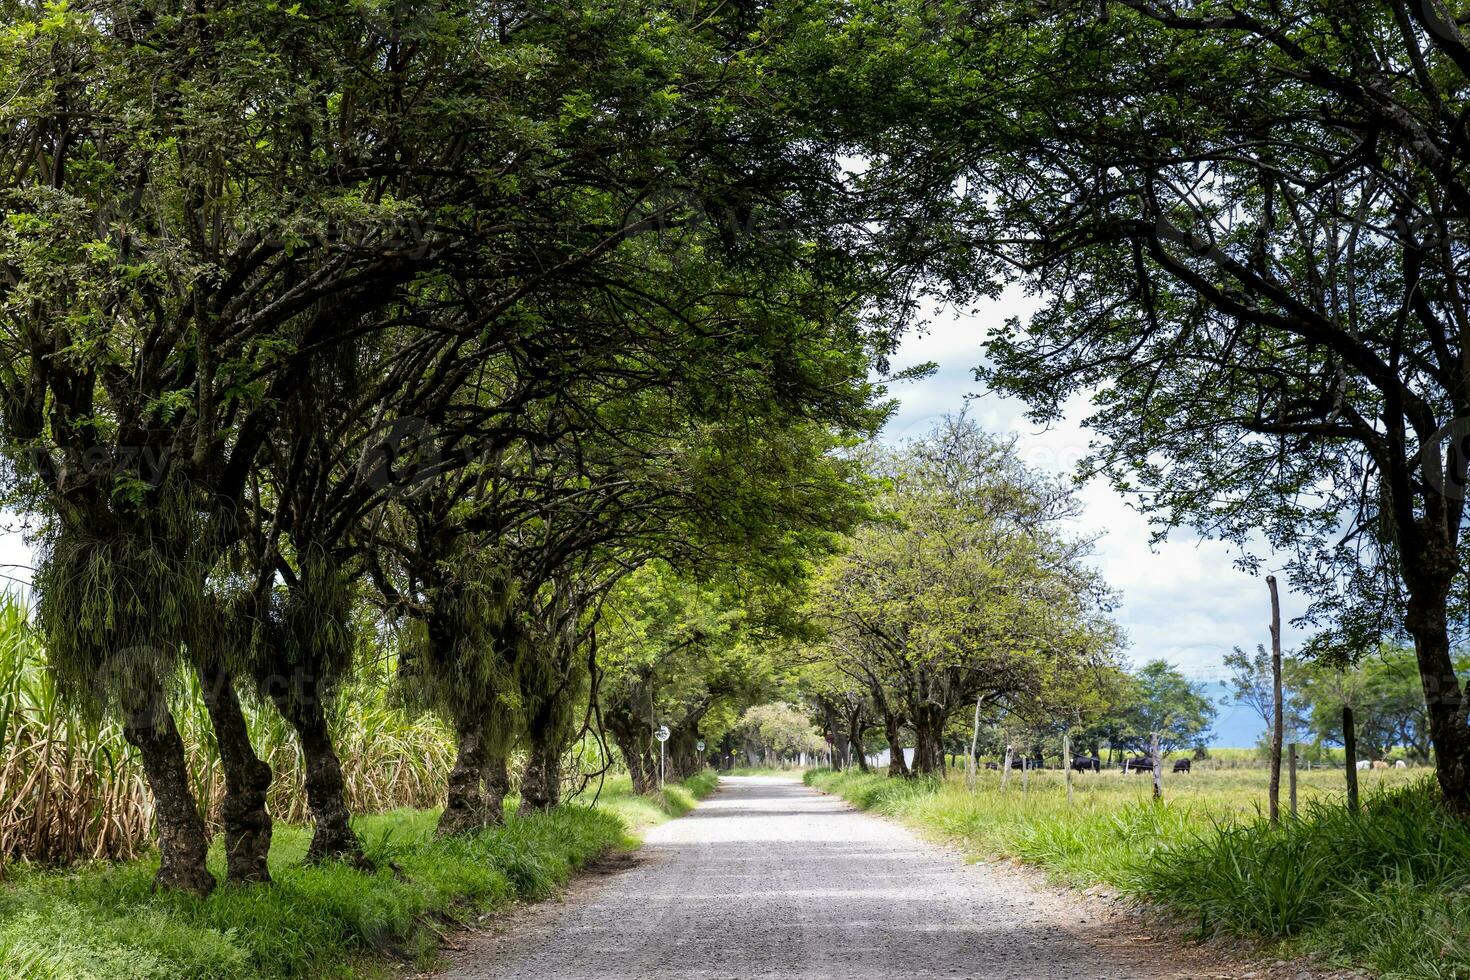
[0,774,716,980]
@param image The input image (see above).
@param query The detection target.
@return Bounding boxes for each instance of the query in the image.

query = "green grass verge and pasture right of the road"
[807,771,1470,980]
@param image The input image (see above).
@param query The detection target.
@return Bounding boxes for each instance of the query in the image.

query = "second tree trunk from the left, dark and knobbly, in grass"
[200,664,270,884]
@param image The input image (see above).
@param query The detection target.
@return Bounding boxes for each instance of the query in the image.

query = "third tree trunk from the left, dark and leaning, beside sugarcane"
[273,674,368,867]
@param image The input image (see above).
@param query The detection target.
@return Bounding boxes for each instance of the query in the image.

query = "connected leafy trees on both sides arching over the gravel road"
[0,0,1470,934]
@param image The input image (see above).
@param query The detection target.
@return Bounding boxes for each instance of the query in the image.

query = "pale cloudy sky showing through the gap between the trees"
[883,295,1305,746]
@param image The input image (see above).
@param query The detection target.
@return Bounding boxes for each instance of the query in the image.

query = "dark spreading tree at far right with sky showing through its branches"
[826,0,1470,810]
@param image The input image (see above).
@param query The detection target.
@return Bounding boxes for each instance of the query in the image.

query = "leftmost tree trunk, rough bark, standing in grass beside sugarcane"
[122,698,215,898]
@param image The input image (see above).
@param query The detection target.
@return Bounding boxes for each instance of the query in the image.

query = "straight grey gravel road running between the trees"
[444,777,1238,980]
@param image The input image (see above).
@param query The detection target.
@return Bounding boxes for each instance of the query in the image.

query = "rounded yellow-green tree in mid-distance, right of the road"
[813,417,1116,773]
